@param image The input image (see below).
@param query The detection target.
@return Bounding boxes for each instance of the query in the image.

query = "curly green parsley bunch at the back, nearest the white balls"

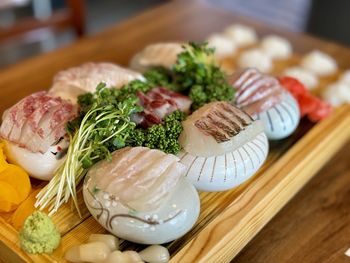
[145,42,234,110]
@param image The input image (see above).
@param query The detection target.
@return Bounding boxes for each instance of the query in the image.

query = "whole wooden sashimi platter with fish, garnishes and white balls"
[0,24,350,263]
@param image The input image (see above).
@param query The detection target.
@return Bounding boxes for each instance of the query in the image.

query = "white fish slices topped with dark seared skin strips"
[179,102,262,157]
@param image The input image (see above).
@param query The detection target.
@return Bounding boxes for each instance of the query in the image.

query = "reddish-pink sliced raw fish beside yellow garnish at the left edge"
[0,91,78,153]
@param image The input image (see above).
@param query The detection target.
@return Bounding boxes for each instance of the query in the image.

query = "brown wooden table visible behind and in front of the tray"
[0,1,350,262]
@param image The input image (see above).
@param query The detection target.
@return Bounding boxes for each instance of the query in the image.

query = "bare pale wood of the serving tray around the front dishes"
[0,106,350,263]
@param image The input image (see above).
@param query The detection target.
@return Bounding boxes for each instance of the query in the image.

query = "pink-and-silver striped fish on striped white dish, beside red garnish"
[229,69,300,140]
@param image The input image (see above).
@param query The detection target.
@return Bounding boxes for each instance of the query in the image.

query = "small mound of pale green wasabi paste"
[19,211,61,254]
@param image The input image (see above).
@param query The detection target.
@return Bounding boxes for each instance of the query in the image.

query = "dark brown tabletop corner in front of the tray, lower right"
[232,142,350,263]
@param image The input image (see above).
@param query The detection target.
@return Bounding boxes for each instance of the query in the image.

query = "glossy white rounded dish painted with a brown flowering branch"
[83,174,200,244]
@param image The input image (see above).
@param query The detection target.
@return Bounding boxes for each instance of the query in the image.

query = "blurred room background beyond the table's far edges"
[0,0,350,69]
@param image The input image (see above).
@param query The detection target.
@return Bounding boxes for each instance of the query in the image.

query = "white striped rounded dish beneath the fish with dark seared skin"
[178,132,269,192]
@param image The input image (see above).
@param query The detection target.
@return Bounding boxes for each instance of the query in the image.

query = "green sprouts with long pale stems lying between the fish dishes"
[36,84,142,216]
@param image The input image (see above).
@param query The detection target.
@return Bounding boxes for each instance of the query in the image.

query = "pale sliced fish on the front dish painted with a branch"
[88,147,185,211]
